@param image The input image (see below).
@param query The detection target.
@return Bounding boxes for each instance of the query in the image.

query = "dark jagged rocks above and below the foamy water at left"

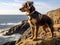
[0,20,30,45]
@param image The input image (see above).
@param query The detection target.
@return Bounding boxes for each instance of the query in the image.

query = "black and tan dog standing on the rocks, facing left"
[19,1,54,40]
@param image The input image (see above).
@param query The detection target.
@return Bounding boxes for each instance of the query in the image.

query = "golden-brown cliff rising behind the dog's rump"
[47,8,60,24]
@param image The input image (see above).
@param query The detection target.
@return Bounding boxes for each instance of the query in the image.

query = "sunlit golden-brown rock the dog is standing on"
[15,27,60,45]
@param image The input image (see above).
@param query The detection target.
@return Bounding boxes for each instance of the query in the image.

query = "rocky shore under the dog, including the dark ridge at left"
[1,8,60,45]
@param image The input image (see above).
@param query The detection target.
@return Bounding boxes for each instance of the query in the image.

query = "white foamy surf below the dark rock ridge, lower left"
[0,34,21,45]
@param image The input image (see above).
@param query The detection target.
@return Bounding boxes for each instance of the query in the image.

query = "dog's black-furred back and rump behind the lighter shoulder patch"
[39,15,53,26]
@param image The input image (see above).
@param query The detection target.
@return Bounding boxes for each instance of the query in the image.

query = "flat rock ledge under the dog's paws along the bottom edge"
[16,39,60,45]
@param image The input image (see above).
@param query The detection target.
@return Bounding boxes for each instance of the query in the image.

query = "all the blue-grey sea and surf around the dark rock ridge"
[0,15,27,45]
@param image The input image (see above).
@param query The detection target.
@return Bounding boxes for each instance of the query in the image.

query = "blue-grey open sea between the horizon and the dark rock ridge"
[0,15,27,30]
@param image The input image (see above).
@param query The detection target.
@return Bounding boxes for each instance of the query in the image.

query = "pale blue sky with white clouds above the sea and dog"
[0,0,60,15]
